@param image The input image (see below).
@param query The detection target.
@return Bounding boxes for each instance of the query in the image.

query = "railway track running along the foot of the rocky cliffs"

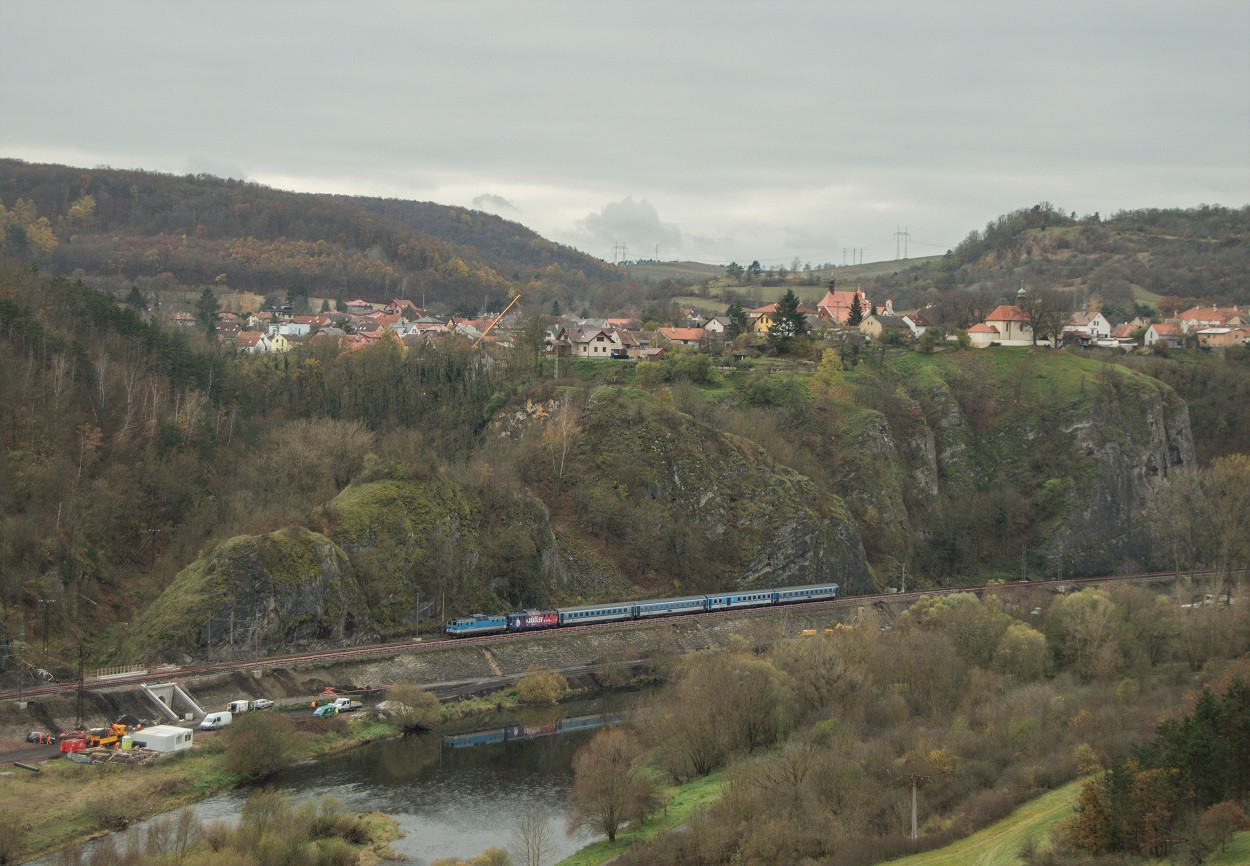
[0,570,1230,700]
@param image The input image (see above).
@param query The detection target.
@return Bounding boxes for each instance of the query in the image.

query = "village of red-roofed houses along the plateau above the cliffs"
[169,281,1250,360]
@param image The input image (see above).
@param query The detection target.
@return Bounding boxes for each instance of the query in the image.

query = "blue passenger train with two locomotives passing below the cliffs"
[444,584,838,637]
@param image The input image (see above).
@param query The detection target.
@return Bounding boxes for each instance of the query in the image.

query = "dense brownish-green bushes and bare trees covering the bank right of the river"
[597,585,1250,865]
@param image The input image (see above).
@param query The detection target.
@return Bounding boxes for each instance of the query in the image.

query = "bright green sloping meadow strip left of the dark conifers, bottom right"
[890,780,1085,866]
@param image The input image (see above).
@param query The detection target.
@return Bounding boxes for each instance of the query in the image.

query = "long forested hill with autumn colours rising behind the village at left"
[0,159,629,310]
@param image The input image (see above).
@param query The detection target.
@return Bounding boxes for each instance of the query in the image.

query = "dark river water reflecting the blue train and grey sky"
[36,696,630,864]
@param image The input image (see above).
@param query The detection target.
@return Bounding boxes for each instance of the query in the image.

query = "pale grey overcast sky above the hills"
[0,0,1250,264]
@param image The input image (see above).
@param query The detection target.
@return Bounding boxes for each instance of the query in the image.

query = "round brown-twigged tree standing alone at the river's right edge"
[569,727,656,841]
